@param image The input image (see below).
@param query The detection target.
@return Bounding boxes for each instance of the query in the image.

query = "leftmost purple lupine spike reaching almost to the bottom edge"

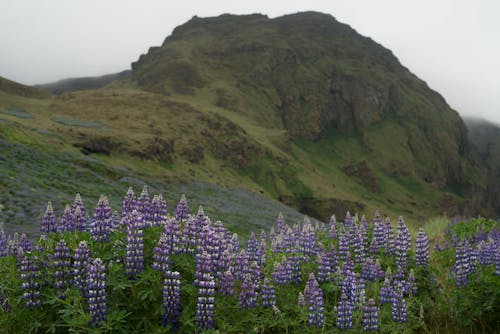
[87,258,107,327]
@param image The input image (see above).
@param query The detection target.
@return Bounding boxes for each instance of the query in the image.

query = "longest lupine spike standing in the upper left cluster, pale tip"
[125,210,144,277]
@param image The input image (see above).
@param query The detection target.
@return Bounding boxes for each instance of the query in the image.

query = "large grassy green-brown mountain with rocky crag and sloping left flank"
[0,12,498,235]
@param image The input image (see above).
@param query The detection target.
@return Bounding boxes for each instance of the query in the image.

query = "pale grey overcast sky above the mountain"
[0,0,500,123]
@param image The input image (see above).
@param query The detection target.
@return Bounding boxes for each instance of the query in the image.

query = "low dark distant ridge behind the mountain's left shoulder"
[35,70,130,94]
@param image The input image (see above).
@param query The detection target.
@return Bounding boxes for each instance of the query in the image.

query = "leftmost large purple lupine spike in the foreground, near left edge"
[19,255,42,308]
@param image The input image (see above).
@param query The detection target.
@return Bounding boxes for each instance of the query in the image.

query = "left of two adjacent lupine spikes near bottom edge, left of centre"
[162,270,181,329]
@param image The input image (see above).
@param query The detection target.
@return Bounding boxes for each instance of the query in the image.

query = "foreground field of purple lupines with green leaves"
[0,188,500,333]
